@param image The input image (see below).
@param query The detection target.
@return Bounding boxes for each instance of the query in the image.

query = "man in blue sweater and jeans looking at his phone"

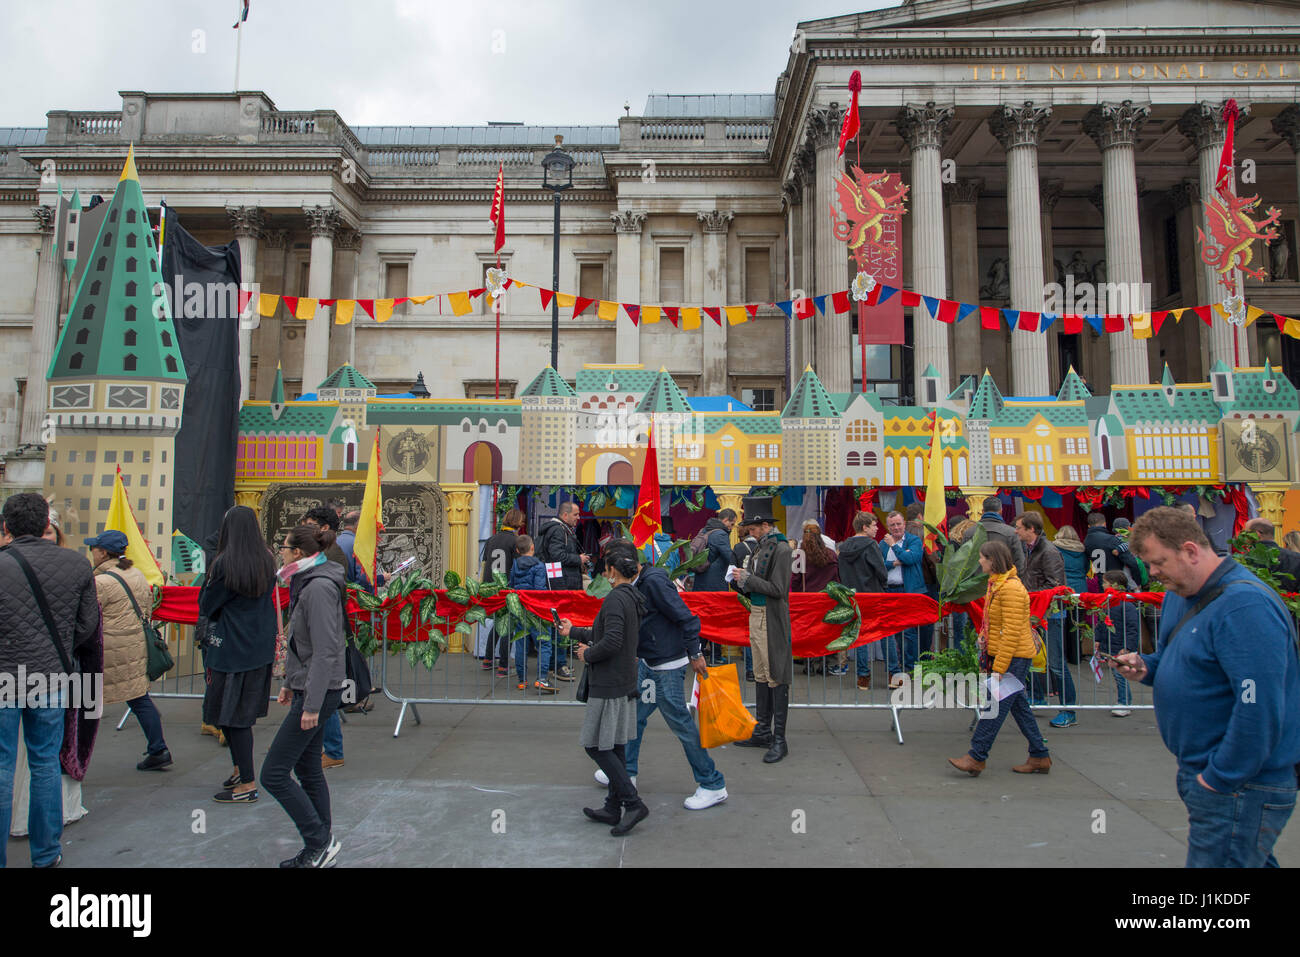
[1117,507,1300,867]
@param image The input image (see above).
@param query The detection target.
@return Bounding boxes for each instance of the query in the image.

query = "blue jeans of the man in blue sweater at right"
[1178,768,1296,867]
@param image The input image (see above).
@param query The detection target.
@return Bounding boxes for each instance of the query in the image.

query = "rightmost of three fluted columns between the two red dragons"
[1083,100,1151,385]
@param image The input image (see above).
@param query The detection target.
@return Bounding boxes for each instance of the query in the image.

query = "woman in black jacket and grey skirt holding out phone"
[559,540,650,836]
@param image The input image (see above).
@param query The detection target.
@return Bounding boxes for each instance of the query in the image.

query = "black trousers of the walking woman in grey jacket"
[261,689,343,848]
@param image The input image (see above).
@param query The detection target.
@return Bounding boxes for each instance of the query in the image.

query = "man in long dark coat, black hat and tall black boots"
[736,497,794,765]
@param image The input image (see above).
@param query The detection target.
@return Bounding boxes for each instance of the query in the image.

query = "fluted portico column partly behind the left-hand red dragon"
[803,110,853,393]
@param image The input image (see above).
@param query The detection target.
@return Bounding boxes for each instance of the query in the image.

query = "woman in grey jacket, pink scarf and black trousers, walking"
[261,525,346,867]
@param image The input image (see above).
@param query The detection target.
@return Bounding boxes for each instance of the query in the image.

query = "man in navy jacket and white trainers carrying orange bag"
[595,548,727,811]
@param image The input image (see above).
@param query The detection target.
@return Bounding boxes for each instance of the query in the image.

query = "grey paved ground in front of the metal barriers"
[9,681,1300,867]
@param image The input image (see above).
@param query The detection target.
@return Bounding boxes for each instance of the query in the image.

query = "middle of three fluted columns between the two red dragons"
[988,100,1052,395]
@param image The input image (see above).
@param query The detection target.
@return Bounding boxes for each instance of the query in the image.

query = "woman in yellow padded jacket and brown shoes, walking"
[948,541,1052,778]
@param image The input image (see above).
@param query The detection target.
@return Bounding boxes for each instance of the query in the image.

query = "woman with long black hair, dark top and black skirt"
[199,505,280,804]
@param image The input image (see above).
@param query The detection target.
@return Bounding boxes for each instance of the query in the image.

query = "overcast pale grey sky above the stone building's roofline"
[0,0,896,126]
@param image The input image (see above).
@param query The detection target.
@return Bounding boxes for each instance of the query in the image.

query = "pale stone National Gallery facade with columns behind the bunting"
[0,0,1300,486]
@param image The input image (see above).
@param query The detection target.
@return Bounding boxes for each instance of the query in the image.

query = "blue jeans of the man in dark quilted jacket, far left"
[0,686,64,867]
